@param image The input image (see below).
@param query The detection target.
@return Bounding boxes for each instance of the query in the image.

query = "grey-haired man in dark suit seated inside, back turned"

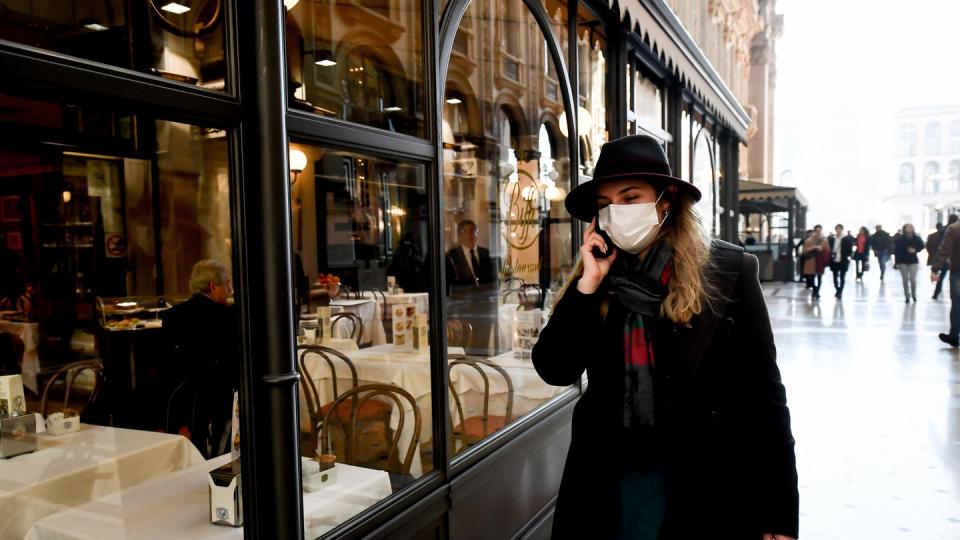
[162,259,240,458]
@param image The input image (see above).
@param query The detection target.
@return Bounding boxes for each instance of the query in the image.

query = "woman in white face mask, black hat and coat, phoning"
[533,135,799,540]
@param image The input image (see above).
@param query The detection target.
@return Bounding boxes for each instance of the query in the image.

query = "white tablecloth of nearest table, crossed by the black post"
[26,454,391,540]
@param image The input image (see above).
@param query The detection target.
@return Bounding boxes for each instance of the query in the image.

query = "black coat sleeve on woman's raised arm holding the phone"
[531,282,603,386]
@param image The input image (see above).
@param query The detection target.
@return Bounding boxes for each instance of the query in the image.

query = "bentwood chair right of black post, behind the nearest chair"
[298,345,390,455]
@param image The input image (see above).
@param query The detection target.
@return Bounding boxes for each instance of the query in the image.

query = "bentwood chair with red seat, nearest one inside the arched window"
[448,356,513,448]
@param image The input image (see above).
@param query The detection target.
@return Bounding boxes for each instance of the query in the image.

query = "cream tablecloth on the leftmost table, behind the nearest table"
[0,424,203,540]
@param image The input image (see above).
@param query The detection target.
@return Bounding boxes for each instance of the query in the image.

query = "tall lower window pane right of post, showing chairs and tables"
[290,143,435,538]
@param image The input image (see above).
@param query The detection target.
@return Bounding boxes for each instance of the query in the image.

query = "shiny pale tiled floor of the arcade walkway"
[764,268,960,540]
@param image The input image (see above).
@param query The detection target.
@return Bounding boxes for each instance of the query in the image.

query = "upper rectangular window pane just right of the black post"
[286,0,426,137]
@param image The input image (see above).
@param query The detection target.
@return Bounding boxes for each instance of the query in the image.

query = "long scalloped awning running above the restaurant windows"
[608,0,750,140]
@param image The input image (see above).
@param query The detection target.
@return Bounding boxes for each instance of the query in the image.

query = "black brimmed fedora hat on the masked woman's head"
[565,135,701,221]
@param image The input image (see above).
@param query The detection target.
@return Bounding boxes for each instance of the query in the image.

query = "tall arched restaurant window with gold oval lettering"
[442,0,576,455]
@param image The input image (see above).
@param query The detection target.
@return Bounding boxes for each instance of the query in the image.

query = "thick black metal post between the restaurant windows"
[234,0,303,539]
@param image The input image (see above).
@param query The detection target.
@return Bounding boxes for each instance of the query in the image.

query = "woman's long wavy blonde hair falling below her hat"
[554,190,718,325]
